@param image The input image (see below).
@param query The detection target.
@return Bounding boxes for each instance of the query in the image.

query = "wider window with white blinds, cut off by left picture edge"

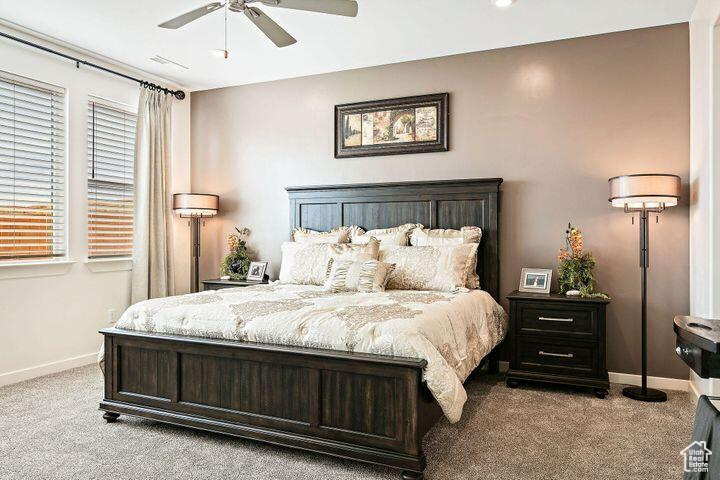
[0,72,66,261]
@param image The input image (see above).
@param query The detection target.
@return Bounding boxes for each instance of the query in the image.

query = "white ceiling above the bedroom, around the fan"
[0,0,696,90]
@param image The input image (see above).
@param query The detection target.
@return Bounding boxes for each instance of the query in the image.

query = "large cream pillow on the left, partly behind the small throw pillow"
[280,238,380,285]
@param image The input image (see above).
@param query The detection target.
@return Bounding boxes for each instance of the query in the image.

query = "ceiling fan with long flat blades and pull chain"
[158,0,358,47]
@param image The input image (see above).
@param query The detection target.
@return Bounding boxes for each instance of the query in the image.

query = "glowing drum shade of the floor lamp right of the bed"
[608,173,681,209]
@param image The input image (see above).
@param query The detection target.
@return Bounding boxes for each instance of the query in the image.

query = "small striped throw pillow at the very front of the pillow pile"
[325,260,395,293]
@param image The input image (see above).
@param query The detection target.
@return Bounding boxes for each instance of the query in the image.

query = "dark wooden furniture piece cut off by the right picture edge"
[673,315,720,378]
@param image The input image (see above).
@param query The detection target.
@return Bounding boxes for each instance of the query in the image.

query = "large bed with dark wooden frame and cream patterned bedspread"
[100,179,504,479]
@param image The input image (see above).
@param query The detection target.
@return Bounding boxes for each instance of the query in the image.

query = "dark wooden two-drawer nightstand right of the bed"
[506,291,609,398]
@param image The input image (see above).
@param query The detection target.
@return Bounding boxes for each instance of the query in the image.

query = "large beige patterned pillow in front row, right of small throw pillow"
[379,243,478,292]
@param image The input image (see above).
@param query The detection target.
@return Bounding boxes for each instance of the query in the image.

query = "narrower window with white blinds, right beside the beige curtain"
[88,100,137,258]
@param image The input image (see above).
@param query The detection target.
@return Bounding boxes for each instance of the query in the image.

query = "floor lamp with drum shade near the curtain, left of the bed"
[173,193,220,293]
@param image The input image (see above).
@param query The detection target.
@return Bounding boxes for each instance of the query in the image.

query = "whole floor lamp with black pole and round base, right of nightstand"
[608,174,681,402]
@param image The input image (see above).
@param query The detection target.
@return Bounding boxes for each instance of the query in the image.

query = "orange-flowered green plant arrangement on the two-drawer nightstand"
[558,223,609,298]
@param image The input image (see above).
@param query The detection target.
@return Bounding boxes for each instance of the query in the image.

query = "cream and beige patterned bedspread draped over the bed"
[111,283,507,422]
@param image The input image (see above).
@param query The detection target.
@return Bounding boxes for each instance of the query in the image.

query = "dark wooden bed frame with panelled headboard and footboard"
[100,179,502,479]
